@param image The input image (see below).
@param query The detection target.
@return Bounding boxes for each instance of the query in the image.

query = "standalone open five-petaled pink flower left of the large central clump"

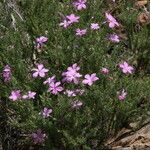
[32,64,49,78]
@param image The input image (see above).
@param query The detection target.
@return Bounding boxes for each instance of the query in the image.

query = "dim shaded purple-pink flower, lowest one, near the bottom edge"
[31,129,46,144]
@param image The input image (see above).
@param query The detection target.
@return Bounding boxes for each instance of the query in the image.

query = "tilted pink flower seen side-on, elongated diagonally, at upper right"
[105,13,119,28]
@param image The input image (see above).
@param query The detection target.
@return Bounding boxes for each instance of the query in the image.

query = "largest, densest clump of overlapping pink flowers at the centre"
[62,63,82,84]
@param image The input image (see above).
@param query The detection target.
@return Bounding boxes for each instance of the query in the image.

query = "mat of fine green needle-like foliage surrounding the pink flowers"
[0,0,150,150]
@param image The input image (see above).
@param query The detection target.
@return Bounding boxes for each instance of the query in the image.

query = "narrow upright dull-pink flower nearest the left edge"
[3,65,12,82]
